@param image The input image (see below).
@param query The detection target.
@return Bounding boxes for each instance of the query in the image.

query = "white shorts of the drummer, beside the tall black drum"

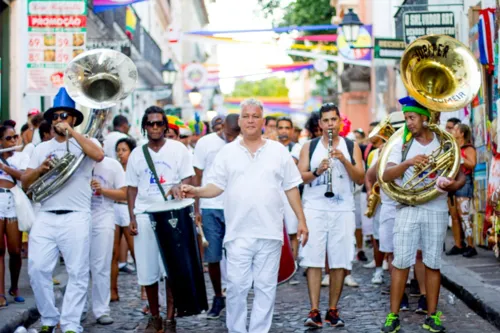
[134,214,165,286]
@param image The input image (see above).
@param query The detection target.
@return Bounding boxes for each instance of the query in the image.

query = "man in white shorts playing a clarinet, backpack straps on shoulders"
[299,103,365,328]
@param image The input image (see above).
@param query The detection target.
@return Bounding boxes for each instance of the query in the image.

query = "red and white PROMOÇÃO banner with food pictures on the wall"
[27,0,87,95]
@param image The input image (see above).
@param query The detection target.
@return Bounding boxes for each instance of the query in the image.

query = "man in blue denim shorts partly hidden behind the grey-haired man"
[193,114,240,319]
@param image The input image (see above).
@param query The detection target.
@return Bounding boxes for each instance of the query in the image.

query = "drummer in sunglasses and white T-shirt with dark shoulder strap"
[126,106,194,332]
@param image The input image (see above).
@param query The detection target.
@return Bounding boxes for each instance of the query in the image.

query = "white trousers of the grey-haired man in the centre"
[225,238,282,333]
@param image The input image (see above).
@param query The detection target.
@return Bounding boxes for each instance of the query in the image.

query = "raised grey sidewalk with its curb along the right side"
[441,231,500,328]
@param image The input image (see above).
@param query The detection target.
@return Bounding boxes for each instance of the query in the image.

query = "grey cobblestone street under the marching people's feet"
[29,256,498,333]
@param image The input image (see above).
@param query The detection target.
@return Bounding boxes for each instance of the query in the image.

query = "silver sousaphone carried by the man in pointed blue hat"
[26,49,138,202]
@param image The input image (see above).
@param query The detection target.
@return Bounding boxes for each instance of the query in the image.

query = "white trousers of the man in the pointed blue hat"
[28,212,90,333]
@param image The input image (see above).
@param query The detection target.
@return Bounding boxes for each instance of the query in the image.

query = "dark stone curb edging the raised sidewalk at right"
[441,267,500,329]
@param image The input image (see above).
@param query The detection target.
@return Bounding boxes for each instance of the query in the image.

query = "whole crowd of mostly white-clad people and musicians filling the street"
[0,88,477,333]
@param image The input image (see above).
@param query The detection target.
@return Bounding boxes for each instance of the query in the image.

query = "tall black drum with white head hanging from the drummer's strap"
[146,199,208,317]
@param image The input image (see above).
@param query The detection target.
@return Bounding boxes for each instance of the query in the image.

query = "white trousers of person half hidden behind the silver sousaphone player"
[85,214,115,319]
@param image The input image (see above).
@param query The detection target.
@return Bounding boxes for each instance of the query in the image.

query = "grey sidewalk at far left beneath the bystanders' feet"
[0,253,67,333]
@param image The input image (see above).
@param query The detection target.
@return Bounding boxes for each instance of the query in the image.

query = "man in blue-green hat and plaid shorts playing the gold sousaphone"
[382,97,465,333]
